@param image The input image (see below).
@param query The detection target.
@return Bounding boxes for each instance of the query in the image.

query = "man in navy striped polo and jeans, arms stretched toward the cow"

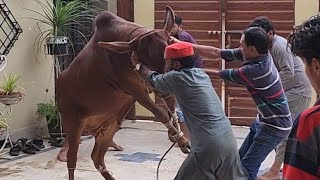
[170,27,292,180]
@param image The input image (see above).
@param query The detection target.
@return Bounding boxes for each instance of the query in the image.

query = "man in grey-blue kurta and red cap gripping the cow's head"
[132,42,248,180]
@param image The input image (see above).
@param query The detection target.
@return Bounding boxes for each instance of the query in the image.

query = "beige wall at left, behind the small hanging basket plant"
[0,0,53,137]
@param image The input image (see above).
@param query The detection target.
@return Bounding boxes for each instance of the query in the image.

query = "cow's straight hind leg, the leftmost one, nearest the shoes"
[61,113,83,180]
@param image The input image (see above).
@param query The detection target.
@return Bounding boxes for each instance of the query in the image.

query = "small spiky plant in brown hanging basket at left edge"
[0,73,25,105]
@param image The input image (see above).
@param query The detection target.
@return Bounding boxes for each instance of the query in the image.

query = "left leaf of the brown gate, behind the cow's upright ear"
[155,0,222,97]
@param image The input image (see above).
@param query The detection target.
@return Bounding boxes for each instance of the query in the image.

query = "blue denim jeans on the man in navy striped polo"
[239,120,284,180]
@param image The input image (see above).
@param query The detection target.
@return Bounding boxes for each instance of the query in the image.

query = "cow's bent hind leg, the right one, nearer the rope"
[91,120,119,180]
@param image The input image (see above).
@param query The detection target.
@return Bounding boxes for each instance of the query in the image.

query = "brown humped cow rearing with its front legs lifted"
[57,7,188,180]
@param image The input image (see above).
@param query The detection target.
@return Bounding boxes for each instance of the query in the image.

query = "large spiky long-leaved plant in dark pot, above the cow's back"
[27,0,99,55]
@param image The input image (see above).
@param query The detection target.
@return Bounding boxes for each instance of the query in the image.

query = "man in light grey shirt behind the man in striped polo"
[249,16,312,180]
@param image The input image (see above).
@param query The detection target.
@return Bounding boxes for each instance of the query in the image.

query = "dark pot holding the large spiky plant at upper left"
[46,36,68,55]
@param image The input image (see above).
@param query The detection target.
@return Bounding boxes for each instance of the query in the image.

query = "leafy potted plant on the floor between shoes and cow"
[36,100,61,138]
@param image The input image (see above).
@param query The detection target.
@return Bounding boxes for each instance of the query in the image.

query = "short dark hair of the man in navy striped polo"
[243,27,269,54]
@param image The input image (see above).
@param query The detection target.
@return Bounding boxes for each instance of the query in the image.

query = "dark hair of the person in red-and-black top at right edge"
[288,14,320,64]
